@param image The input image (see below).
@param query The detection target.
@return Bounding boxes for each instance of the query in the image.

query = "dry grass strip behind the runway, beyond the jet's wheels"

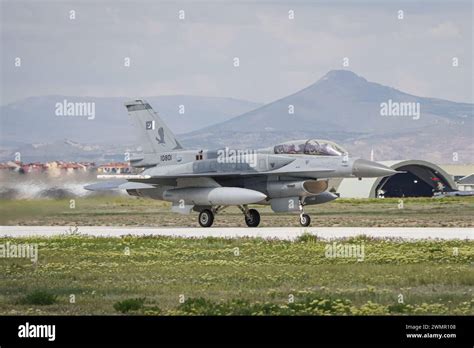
[0,197,474,227]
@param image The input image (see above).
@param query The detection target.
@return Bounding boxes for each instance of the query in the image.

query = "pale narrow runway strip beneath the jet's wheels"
[0,226,474,240]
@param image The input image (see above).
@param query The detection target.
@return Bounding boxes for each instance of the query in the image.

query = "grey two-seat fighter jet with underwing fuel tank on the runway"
[85,99,398,227]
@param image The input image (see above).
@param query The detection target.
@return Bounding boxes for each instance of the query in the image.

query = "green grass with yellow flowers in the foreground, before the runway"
[0,234,474,315]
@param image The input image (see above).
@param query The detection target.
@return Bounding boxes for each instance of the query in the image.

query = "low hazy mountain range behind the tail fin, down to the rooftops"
[0,95,261,162]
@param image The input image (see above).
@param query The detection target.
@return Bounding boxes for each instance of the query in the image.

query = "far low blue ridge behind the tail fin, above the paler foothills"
[0,95,261,145]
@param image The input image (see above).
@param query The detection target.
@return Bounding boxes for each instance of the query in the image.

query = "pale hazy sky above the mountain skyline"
[0,0,474,104]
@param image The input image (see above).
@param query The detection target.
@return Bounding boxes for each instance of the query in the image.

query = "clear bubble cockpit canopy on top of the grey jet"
[273,139,347,156]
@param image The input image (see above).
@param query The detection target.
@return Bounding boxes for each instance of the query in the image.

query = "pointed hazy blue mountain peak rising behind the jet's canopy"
[181,70,474,163]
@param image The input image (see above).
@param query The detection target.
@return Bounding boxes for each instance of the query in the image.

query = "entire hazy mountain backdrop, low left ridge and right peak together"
[0,70,474,163]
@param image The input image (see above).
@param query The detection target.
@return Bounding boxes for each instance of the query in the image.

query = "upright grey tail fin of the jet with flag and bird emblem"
[125,99,183,154]
